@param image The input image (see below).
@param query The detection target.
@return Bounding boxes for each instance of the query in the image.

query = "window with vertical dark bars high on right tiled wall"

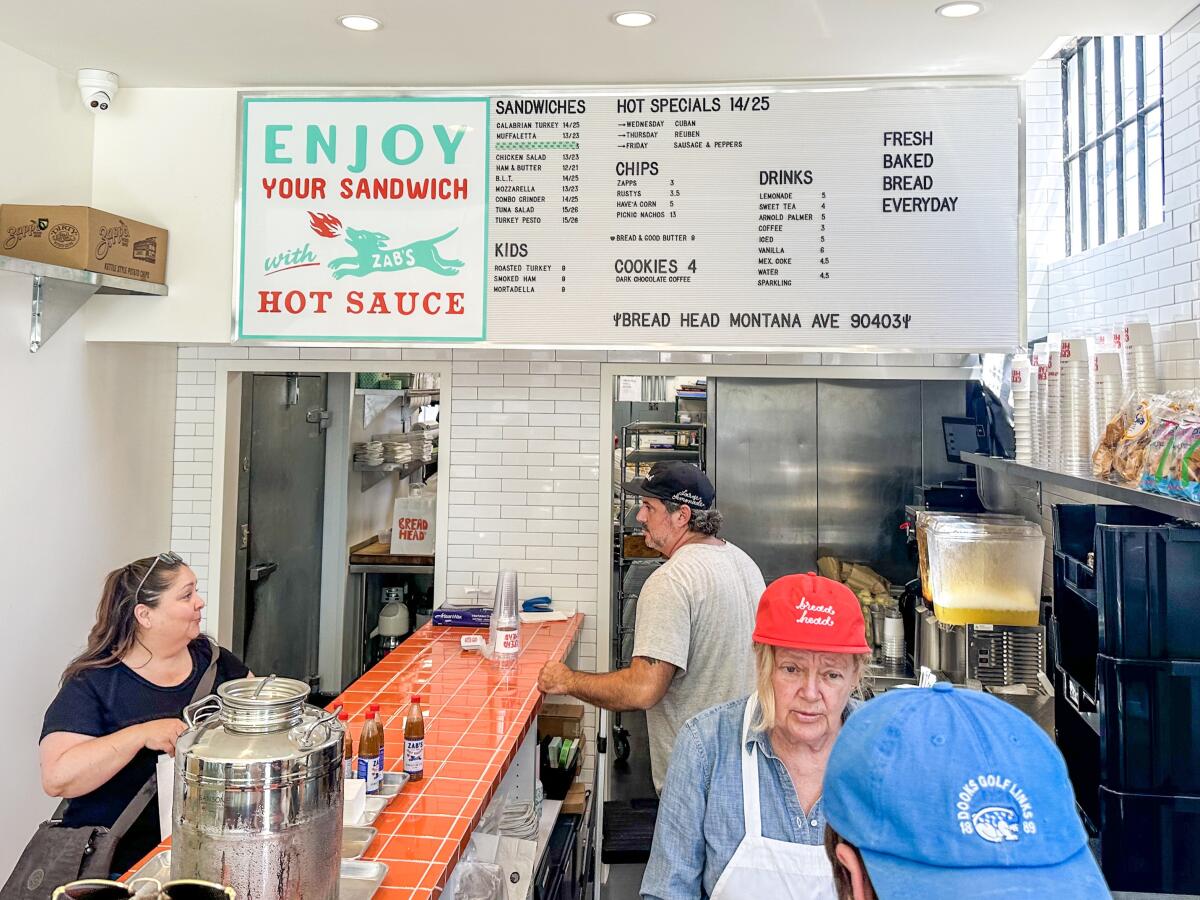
[1062,36,1165,256]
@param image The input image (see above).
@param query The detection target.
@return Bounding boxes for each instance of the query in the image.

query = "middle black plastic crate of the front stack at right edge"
[1097,655,1200,796]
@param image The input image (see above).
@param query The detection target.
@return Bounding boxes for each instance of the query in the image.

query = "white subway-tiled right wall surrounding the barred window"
[1025,15,1200,585]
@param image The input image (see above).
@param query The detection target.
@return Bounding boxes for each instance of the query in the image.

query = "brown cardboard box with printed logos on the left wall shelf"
[0,203,167,284]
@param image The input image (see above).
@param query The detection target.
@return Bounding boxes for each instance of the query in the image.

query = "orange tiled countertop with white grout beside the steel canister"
[126,613,583,900]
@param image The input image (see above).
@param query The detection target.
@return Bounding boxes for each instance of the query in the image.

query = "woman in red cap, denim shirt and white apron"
[642,572,871,900]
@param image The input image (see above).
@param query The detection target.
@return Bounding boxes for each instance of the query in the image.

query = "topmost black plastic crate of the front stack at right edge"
[1096,524,1200,660]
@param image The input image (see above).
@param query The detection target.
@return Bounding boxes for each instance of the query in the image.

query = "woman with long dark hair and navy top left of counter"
[40,553,248,872]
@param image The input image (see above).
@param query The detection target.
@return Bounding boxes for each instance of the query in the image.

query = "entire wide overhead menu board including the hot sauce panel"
[235,85,1021,352]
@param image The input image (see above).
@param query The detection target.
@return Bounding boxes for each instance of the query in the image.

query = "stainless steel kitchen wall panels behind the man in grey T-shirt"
[708,378,965,582]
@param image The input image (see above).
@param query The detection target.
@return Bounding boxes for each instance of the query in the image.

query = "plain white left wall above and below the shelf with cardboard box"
[0,43,174,880]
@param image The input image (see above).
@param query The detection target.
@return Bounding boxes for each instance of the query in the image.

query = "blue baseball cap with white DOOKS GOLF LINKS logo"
[823,682,1110,900]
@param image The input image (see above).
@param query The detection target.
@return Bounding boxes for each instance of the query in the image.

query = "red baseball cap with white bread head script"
[754,572,871,653]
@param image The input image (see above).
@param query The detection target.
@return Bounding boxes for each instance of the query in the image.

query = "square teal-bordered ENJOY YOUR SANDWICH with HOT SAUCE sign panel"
[234,96,488,342]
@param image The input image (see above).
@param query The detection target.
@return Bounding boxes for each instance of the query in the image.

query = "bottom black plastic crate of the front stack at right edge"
[1100,787,1200,894]
